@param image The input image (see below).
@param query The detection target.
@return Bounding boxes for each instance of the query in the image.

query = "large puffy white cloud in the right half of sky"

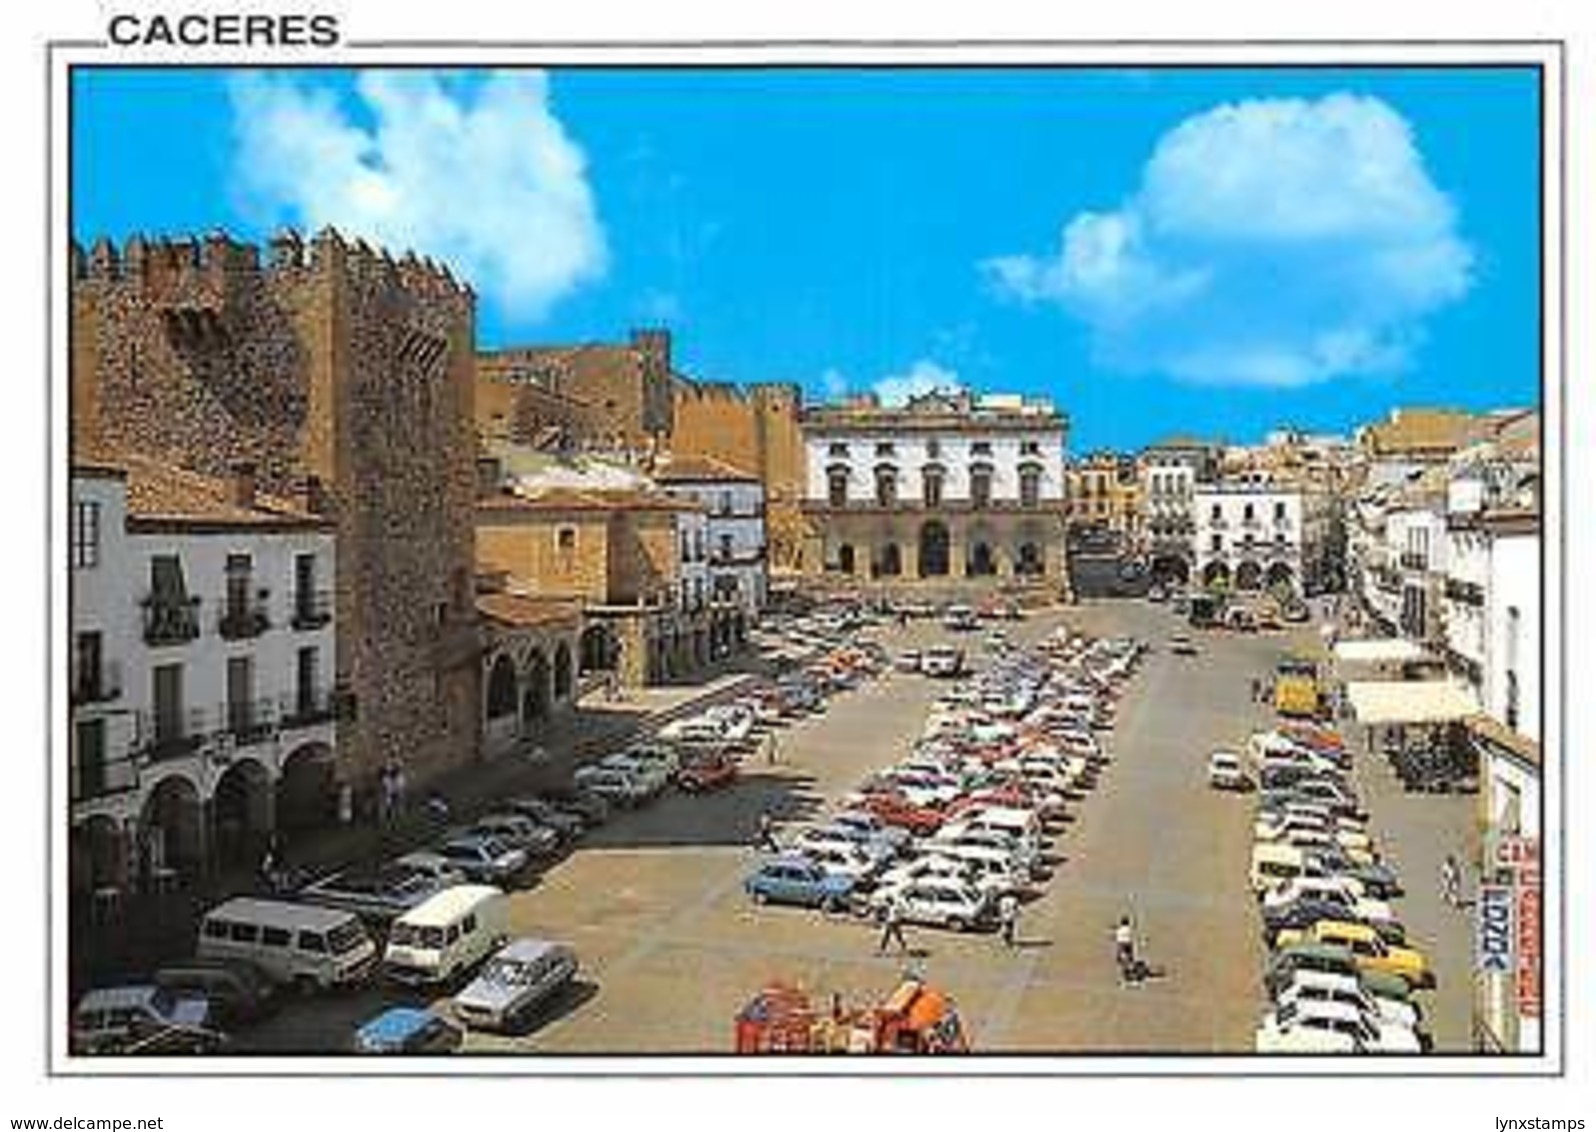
[983,94,1473,386]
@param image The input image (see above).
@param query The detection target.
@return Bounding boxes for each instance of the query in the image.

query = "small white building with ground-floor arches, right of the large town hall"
[1192,479,1328,596]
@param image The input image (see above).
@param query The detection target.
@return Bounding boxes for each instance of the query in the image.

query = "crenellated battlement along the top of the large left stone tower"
[69,227,474,300]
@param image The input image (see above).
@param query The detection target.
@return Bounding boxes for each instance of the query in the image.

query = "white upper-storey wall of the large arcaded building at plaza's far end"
[804,428,1065,506]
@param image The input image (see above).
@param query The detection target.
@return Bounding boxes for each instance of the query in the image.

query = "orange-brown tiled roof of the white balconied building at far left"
[72,447,334,530]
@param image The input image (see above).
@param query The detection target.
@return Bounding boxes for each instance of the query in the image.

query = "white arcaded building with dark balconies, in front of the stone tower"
[67,455,342,904]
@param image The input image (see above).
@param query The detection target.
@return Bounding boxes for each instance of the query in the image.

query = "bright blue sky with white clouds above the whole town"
[72,69,1540,450]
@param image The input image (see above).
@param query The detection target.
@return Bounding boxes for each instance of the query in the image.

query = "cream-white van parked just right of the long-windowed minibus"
[383,885,509,984]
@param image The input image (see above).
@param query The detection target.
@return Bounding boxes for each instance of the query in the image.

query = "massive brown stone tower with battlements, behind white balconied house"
[70,230,480,787]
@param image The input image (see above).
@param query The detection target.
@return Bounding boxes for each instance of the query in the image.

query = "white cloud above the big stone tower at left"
[231,70,608,318]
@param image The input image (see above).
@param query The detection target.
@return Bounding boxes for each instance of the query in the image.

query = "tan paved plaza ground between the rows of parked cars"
[239,602,1470,1054]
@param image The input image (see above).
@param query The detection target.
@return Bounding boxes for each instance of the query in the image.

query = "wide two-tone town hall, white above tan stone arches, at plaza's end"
[803,393,1066,592]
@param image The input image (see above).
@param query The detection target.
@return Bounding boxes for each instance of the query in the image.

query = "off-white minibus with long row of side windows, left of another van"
[196,896,377,990]
